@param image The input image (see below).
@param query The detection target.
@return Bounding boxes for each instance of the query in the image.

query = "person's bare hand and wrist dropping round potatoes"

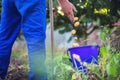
[58,0,76,22]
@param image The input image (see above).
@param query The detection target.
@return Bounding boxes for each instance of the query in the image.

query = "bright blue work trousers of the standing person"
[0,0,47,80]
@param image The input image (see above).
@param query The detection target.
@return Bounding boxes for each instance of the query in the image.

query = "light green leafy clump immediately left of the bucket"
[54,54,74,80]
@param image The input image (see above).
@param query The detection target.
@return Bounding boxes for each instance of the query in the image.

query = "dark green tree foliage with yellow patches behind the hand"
[46,0,120,42]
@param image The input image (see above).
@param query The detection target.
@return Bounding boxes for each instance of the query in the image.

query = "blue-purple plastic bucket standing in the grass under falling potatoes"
[68,45,100,72]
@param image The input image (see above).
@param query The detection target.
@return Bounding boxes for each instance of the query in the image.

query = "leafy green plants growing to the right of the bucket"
[80,28,120,80]
